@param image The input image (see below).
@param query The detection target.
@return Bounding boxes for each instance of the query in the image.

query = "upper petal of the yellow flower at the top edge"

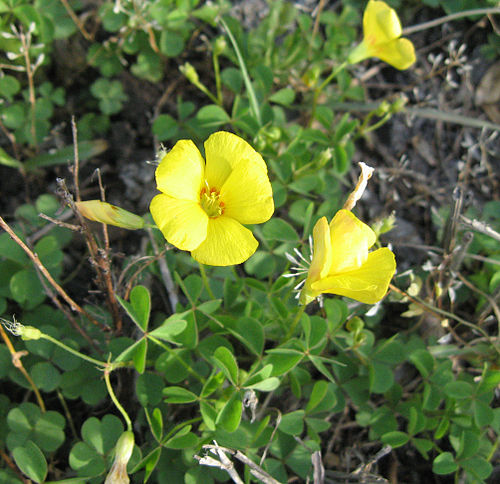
[363,0,402,44]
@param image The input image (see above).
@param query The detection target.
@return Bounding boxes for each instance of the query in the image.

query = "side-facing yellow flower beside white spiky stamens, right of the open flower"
[300,209,396,304]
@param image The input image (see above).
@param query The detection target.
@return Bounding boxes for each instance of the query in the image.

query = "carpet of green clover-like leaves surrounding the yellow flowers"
[0,0,500,484]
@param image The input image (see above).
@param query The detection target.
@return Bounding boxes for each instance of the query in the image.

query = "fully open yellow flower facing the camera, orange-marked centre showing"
[150,131,274,266]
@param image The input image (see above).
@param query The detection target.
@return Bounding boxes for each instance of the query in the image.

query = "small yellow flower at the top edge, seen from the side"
[347,0,415,70]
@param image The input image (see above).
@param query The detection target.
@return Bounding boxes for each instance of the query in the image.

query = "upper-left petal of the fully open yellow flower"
[156,140,205,201]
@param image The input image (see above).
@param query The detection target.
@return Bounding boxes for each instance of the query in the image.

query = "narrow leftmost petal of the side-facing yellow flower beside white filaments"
[299,217,332,304]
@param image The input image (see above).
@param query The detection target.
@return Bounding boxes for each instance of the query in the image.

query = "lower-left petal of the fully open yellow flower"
[149,194,208,251]
